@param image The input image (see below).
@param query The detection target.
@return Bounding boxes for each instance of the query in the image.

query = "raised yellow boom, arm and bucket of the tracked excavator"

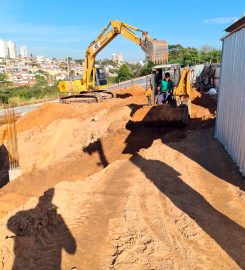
[82,20,168,88]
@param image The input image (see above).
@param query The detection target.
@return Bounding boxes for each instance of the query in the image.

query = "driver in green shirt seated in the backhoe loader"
[157,72,173,104]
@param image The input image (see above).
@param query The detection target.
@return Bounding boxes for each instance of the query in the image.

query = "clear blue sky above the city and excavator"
[0,0,245,60]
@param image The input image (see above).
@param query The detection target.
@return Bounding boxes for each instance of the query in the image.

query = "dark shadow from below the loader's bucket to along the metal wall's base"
[126,102,245,190]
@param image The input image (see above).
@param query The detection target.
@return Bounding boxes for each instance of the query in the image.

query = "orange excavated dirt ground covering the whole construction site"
[0,86,245,270]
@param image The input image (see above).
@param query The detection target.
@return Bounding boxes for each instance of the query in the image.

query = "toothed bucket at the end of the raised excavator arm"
[141,39,168,64]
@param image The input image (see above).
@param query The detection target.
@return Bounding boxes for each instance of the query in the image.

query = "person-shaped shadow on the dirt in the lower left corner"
[7,188,76,270]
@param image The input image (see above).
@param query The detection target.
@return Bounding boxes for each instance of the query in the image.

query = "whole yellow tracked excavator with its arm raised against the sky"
[59,20,168,103]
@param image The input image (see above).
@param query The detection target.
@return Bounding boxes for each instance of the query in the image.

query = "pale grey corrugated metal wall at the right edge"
[215,28,245,176]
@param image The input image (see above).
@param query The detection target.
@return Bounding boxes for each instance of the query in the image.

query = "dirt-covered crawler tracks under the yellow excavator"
[60,91,116,104]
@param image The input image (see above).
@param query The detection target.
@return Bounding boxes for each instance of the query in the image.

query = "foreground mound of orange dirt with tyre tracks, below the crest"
[0,130,245,270]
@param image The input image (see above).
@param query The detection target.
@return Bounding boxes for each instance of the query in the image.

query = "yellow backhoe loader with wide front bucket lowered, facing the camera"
[134,64,191,126]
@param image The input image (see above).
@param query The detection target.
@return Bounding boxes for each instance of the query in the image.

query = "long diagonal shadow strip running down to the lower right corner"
[131,154,245,269]
